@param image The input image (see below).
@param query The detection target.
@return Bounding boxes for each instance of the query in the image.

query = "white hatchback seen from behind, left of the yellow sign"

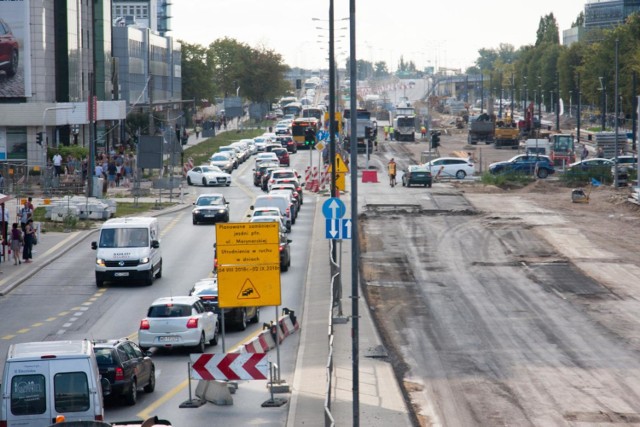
[138,296,220,353]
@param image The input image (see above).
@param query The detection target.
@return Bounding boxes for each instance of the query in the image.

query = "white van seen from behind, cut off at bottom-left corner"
[0,340,110,427]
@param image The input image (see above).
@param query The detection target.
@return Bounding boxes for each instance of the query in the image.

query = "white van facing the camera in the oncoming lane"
[91,217,162,287]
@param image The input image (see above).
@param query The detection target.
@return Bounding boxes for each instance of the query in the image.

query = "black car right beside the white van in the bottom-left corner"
[93,338,156,405]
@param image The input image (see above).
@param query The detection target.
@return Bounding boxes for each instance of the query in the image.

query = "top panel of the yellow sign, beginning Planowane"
[216,222,280,246]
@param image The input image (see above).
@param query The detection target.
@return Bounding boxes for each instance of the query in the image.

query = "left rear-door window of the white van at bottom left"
[11,374,47,415]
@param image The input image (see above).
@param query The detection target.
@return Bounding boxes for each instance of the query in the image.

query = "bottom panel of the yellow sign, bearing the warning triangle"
[218,263,281,308]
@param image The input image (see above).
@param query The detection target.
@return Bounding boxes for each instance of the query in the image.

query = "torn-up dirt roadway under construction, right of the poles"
[358,115,640,426]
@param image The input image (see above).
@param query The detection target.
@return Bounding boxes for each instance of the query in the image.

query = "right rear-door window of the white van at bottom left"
[53,372,91,413]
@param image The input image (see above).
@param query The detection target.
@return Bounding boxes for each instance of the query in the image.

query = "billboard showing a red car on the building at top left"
[0,0,31,98]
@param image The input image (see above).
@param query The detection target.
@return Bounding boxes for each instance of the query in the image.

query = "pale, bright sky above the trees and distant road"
[169,0,585,71]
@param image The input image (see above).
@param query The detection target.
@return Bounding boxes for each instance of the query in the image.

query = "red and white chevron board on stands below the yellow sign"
[191,353,269,381]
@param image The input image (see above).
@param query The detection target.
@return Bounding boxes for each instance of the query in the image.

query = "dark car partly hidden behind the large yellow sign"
[189,277,260,331]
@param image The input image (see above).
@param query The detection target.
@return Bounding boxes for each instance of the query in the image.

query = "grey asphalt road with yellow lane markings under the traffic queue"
[0,146,315,426]
